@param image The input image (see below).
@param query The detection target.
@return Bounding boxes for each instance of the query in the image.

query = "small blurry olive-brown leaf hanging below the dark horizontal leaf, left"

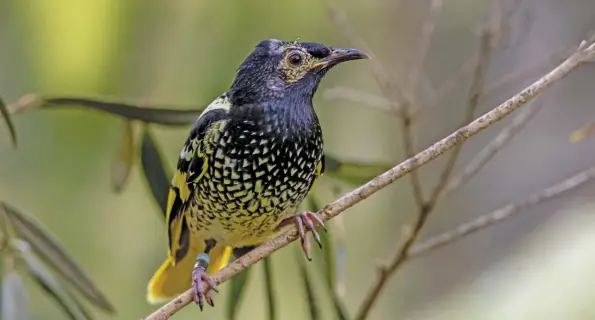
[111,121,134,192]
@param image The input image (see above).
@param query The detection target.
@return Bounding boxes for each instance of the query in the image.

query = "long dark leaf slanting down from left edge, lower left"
[0,202,114,313]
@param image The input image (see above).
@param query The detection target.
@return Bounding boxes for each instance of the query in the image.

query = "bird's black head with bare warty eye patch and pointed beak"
[230,39,369,104]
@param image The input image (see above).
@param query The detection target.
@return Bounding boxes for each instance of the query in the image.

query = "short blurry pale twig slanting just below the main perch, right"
[448,100,543,199]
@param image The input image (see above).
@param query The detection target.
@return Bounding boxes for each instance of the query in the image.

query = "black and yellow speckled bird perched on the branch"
[147,39,369,310]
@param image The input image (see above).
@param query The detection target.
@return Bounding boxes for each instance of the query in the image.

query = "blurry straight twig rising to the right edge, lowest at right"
[409,167,595,258]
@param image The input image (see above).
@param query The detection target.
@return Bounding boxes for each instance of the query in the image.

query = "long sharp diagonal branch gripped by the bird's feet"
[145,36,595,320]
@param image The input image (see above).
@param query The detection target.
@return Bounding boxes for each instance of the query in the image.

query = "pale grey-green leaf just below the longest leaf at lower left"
[11,239,91,320]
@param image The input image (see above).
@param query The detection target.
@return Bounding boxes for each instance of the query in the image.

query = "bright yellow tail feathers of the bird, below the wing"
[147,244,232,304]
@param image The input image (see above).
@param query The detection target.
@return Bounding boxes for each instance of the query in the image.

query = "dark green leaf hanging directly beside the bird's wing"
[141,126,170,217]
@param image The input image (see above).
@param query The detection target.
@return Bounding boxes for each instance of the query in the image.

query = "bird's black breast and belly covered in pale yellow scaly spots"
[186,97,323,246]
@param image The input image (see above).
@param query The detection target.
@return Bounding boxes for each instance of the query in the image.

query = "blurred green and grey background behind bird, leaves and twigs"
[0,0,595,319]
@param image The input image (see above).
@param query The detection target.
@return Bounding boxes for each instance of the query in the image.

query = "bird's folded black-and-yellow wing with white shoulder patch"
[165,95,231,263]
